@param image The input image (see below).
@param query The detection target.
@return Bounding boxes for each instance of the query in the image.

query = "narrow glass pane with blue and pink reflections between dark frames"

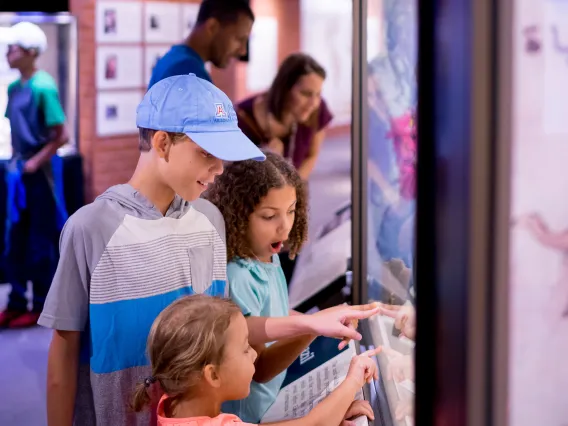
[367,0,417,426]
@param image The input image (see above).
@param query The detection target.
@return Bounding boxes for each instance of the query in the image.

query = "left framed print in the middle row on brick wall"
[97,46,144,89]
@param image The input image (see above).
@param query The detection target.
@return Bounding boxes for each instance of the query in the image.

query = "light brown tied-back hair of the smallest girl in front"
[132,295,241,412]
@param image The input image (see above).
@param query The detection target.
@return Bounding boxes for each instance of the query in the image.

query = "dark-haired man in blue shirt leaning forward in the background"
[148,0,254,88]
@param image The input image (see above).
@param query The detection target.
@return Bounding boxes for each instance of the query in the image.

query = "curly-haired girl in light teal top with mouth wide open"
[204,152,360,423]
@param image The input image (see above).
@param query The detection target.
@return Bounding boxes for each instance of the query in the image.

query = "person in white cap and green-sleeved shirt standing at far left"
[0,22,68,328]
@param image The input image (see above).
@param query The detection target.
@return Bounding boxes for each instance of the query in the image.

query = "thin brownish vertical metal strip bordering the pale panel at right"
[488,0,515,425]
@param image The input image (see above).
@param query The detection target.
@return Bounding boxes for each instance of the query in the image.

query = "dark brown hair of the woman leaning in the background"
[266,53,326,120]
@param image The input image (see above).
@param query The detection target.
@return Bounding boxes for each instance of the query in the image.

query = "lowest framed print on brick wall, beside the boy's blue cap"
[97,90,144,137]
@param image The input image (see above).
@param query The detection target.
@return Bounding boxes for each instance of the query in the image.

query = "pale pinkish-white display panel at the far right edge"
[505,0,568,426]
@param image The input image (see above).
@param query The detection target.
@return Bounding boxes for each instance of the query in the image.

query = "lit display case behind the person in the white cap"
[0,13,77,160]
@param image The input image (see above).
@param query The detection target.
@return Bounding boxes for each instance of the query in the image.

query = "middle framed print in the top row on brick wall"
[144,2,181,44]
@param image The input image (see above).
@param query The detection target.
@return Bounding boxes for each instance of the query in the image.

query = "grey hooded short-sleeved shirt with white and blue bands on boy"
[38,185,228,426]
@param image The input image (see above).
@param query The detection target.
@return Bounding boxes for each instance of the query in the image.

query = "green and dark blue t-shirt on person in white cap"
[5,71,65,159]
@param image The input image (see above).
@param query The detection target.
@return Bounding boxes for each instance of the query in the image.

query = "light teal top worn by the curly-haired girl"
[223,255,289,424]
